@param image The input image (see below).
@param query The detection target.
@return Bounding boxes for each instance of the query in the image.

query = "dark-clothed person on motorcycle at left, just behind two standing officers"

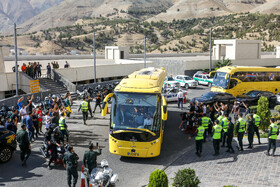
[47,128,63,169]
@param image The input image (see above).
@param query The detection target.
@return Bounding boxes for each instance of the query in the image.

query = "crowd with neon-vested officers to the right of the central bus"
[178,98,280,157]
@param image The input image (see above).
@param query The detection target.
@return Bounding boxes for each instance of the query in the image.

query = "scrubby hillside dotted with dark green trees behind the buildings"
[0,13,280,54]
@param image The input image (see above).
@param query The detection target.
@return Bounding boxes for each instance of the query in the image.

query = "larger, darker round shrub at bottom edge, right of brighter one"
[172,168,200,187]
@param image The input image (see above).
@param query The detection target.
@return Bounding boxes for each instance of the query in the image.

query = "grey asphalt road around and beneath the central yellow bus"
[0,86,209,187]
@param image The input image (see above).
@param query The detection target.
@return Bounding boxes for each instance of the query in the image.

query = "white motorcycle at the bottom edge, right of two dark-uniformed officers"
[84,159,119,187]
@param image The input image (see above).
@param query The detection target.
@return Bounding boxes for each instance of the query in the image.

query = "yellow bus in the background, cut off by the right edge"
[211,66,280,97]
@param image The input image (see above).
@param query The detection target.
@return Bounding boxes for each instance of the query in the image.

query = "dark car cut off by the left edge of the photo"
[0,127,17,163]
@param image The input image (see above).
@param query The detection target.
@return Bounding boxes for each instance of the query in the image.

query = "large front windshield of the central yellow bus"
[111,92,160,135]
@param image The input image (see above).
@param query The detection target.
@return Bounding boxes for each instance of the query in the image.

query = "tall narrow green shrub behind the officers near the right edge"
[257,96,271,130]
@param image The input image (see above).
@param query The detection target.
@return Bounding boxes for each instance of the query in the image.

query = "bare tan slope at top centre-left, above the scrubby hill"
[17,0,172,32]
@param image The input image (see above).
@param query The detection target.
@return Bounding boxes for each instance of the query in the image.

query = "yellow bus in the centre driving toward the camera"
[102,68,167,158]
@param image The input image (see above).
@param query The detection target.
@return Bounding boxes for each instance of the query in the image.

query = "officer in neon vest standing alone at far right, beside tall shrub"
[266,118,279,156]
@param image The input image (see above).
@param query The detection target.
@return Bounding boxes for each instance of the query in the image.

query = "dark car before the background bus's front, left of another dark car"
[191,92,236,104]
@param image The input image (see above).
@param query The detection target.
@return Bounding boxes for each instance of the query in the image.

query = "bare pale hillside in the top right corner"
[149,0,280,22]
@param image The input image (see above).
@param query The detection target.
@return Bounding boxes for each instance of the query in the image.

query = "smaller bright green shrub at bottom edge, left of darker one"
[148,169,168,187]
